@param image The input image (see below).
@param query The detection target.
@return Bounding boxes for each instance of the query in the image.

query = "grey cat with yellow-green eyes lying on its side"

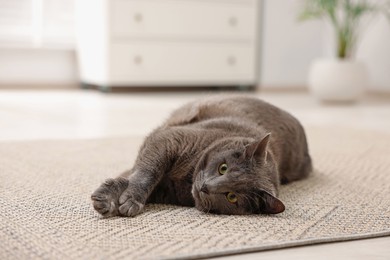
[91,96,312,217]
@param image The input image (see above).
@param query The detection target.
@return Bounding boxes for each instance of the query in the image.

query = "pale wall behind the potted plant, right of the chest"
[261,0,390,92]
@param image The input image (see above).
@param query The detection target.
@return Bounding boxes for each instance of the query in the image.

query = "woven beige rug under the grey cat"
[0,128,390,259]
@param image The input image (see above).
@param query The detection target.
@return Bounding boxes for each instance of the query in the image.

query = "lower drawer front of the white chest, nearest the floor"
[110,42,256,83]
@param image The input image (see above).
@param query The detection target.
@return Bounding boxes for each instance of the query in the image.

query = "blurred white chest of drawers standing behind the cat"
[75,0,260,90]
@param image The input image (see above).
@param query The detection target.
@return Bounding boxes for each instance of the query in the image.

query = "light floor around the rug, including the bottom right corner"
[0,90,390,259]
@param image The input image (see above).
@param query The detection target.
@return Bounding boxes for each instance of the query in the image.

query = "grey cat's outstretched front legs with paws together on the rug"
[92,130,178,217]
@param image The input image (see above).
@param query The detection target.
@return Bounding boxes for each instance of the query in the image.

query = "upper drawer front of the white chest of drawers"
[110,0,258,39]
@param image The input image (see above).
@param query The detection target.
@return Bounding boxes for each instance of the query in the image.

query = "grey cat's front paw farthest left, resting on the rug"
[91,178,129,217]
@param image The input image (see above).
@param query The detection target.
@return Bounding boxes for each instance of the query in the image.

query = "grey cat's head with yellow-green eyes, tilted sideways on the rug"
[192,134,284,215]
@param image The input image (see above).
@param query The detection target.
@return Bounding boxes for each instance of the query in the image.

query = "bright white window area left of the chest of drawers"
[0,0,74,49]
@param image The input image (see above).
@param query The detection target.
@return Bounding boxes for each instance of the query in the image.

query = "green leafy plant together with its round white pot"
[299,0,390,102]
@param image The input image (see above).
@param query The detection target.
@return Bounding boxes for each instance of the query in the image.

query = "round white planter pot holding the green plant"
[309,59,368,102]
